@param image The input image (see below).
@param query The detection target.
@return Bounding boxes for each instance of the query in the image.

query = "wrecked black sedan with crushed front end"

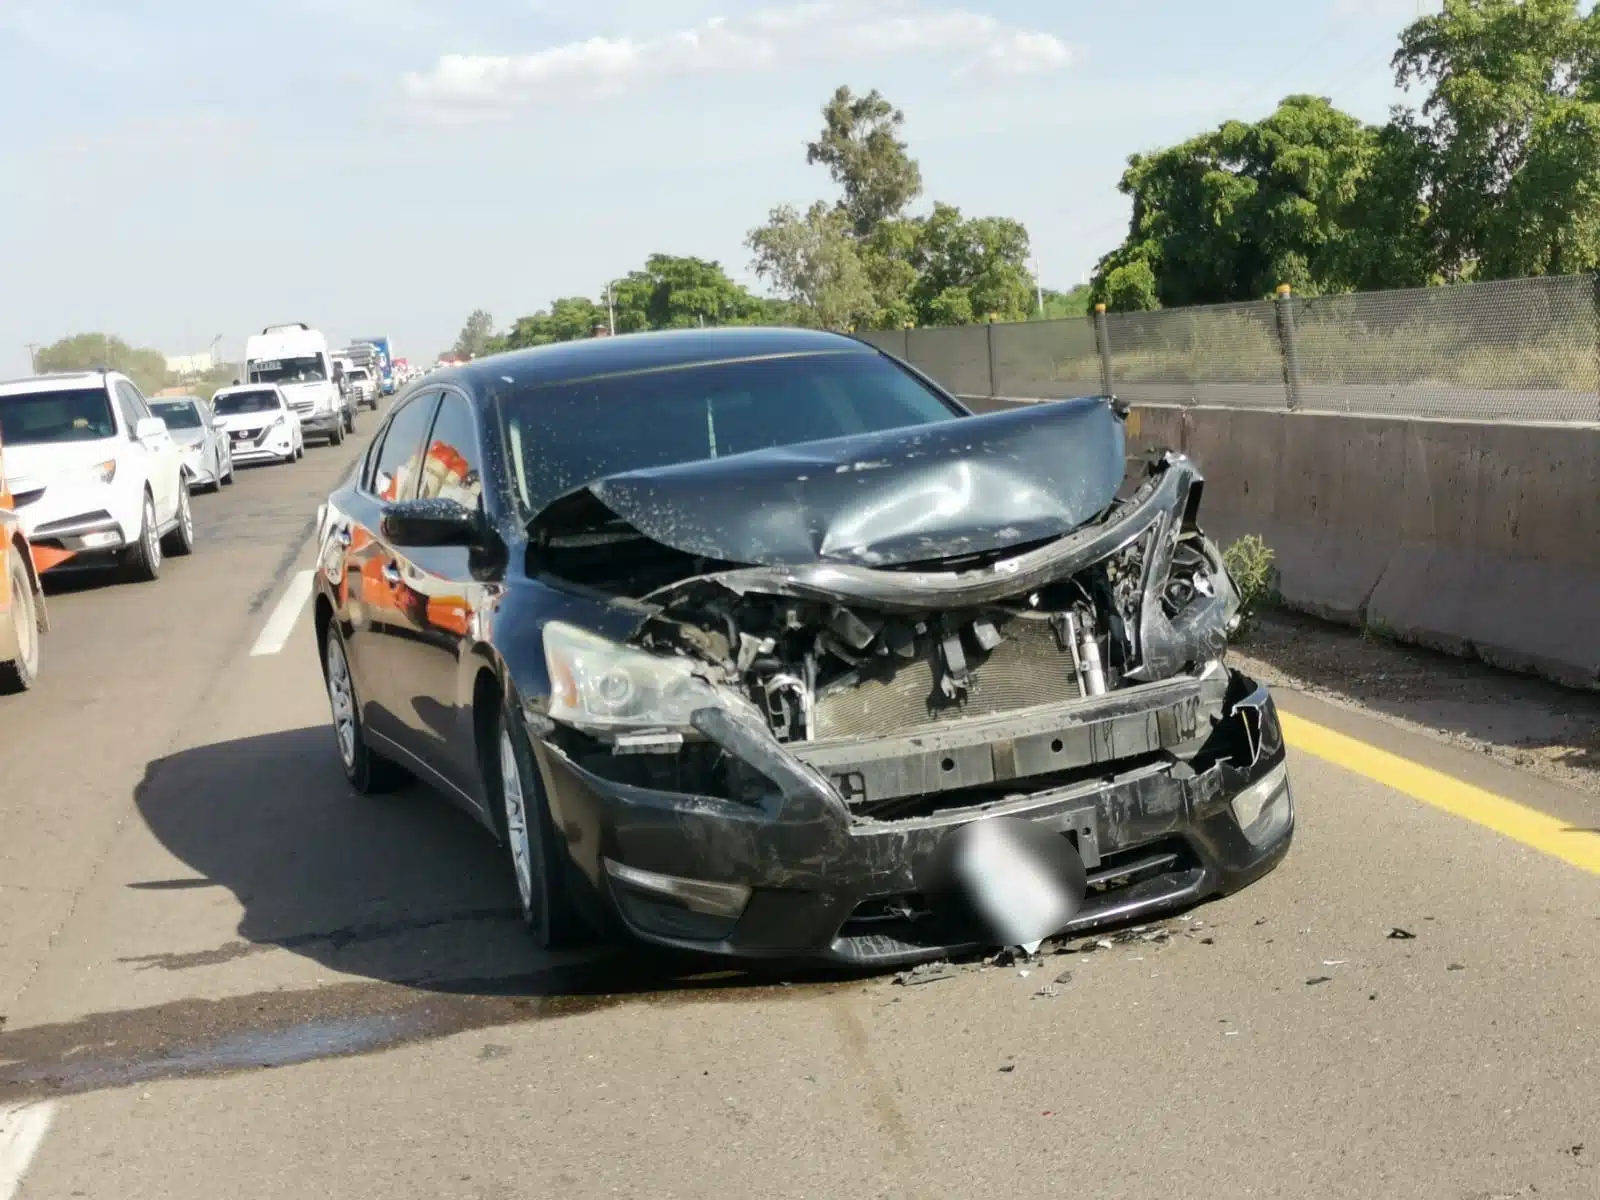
[315,330,1294,965]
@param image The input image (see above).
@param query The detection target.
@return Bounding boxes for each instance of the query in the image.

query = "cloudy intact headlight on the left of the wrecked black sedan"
[544,621,754,730]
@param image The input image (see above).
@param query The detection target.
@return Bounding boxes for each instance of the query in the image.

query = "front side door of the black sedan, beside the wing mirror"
[382,387,493,798]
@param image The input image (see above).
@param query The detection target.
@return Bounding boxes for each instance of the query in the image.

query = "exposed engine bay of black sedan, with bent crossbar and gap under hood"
[531,438,1238,764]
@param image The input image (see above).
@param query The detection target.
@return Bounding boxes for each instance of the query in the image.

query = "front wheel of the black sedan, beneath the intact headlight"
[485,707,592,949]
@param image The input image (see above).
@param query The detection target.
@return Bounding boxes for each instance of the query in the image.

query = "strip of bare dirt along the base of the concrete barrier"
[1229,610,1600,795]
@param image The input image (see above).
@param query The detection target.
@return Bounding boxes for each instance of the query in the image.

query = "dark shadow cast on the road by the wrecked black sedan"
[130,726,829,995]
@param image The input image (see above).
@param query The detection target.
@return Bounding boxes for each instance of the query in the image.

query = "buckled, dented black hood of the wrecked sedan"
[531,397,1125,566]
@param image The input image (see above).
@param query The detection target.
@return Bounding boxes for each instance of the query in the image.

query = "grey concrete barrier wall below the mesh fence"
[966,396,1600,688]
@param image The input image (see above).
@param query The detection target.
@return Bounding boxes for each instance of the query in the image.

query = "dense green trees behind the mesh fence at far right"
[1093,0,1600,309]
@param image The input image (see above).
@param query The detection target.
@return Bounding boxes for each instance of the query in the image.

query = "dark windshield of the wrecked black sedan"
[502,352,960,512]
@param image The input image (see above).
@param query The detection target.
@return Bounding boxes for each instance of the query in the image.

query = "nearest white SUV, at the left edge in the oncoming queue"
[0,371,195,581]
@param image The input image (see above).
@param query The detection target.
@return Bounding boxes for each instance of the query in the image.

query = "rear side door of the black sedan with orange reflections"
[330,390,438,755]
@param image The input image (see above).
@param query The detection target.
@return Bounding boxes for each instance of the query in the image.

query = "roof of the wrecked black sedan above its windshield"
[434,325,878,386]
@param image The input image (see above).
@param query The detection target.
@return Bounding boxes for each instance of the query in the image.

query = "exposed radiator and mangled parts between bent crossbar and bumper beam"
[642,459,1238,742]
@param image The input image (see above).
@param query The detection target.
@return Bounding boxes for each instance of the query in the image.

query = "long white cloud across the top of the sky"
[405,0,1072,115]
